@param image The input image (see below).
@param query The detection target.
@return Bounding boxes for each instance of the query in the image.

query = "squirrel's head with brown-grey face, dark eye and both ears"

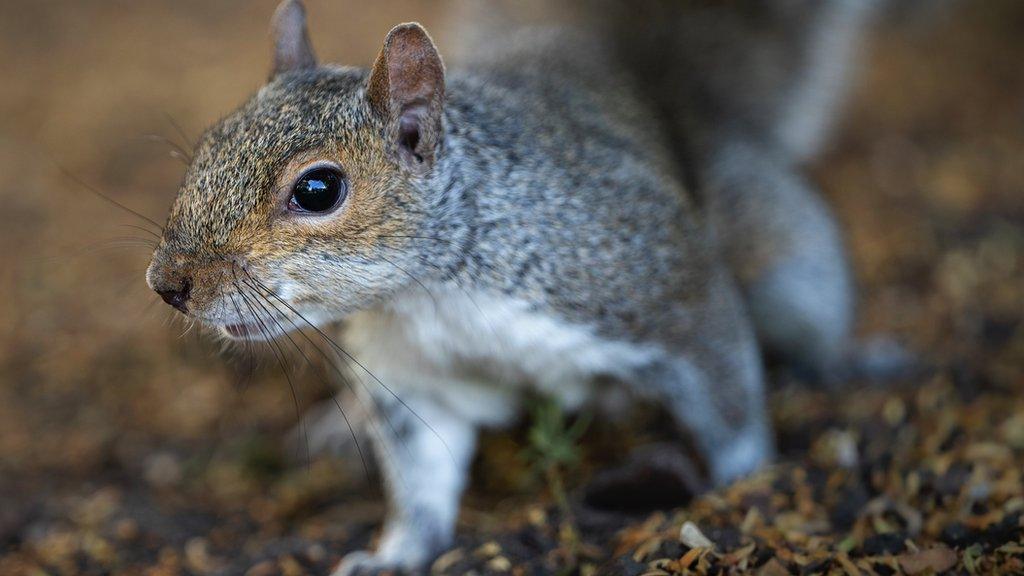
[146,0,444,339]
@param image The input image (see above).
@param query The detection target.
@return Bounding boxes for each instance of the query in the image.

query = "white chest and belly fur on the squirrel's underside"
[344,286,657,425]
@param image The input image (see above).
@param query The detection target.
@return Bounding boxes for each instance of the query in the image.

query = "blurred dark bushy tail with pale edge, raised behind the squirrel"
[450,0,888,166]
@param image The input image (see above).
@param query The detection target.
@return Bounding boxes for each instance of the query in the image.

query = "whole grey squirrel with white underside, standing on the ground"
[146,0,897,575]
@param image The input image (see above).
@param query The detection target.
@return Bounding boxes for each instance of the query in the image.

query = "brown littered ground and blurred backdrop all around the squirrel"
[0,0,1024,576]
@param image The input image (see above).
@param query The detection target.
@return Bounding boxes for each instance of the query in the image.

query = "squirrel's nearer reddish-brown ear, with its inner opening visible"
[367,23,444,168]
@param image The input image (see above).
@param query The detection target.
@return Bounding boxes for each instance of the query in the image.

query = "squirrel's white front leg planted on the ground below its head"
[334,389,476,576]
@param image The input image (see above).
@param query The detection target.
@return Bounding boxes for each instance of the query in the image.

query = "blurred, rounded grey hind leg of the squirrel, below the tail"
[705,142,888,384]
